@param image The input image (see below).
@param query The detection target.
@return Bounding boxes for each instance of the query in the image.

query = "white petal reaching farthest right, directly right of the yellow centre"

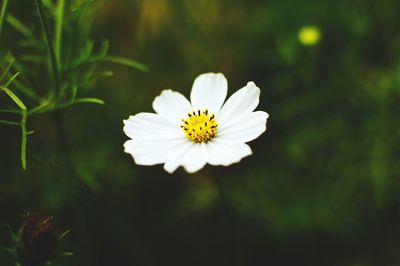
[217,111,268,142]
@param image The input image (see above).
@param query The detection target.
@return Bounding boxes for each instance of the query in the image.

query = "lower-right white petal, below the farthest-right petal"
[206,139,252,166]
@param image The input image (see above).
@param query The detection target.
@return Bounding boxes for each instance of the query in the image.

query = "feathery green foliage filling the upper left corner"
[0,0,147,169]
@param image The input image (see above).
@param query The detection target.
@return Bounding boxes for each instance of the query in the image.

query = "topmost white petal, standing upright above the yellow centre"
[190,73,228,114]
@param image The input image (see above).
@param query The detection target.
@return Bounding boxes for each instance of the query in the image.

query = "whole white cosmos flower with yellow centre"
[124,73,268,173]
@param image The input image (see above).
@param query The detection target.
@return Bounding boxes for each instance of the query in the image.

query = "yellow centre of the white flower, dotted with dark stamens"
[181,109,218,142]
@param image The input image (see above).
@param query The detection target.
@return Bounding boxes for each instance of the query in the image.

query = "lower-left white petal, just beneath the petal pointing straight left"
[124,138,186,165]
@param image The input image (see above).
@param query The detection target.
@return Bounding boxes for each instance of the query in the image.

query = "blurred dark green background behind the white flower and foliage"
[0,0,400,266]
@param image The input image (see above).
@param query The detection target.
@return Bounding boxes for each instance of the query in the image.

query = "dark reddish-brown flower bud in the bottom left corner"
[15,210,57,266]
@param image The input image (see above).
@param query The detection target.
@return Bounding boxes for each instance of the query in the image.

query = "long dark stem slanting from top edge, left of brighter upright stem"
[35,0,61,101]
